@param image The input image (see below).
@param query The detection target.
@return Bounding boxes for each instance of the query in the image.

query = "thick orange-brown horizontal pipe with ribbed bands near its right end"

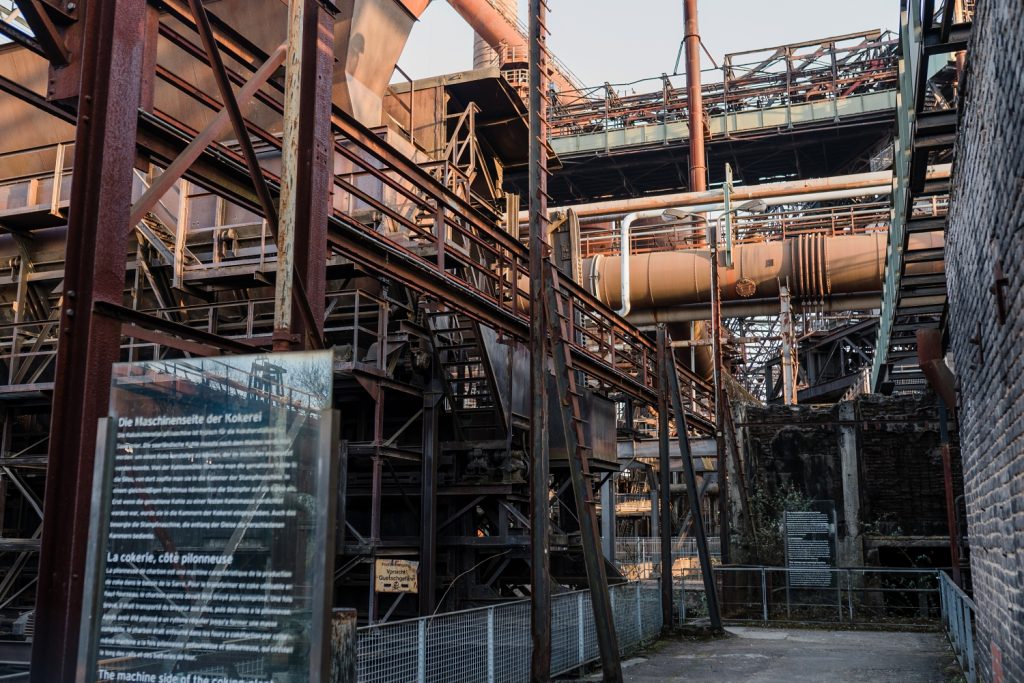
[585,232,943,311]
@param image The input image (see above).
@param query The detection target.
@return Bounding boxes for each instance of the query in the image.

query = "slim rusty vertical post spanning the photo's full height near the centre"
[528,0,551,682]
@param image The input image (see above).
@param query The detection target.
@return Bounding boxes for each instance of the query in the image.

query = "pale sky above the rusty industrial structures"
[398,0,899,86]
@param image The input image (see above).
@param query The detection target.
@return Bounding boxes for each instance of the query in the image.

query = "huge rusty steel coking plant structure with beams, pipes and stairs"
[0,0,983,682]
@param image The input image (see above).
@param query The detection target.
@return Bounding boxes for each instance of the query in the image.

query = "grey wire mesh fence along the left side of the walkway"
[357,582,662,683]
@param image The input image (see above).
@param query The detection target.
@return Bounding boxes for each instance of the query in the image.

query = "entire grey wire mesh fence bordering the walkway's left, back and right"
[358,566,946,683]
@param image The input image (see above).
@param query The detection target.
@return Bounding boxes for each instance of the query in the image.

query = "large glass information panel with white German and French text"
[79,351,337,683]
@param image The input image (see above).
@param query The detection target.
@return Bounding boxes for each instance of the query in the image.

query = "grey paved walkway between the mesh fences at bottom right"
[606,628,961,683]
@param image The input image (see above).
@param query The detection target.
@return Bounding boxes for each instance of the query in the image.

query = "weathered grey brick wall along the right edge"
[946,0,1024,683]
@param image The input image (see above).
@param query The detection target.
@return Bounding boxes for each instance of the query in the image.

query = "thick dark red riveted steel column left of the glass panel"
[31,0,152,683]
